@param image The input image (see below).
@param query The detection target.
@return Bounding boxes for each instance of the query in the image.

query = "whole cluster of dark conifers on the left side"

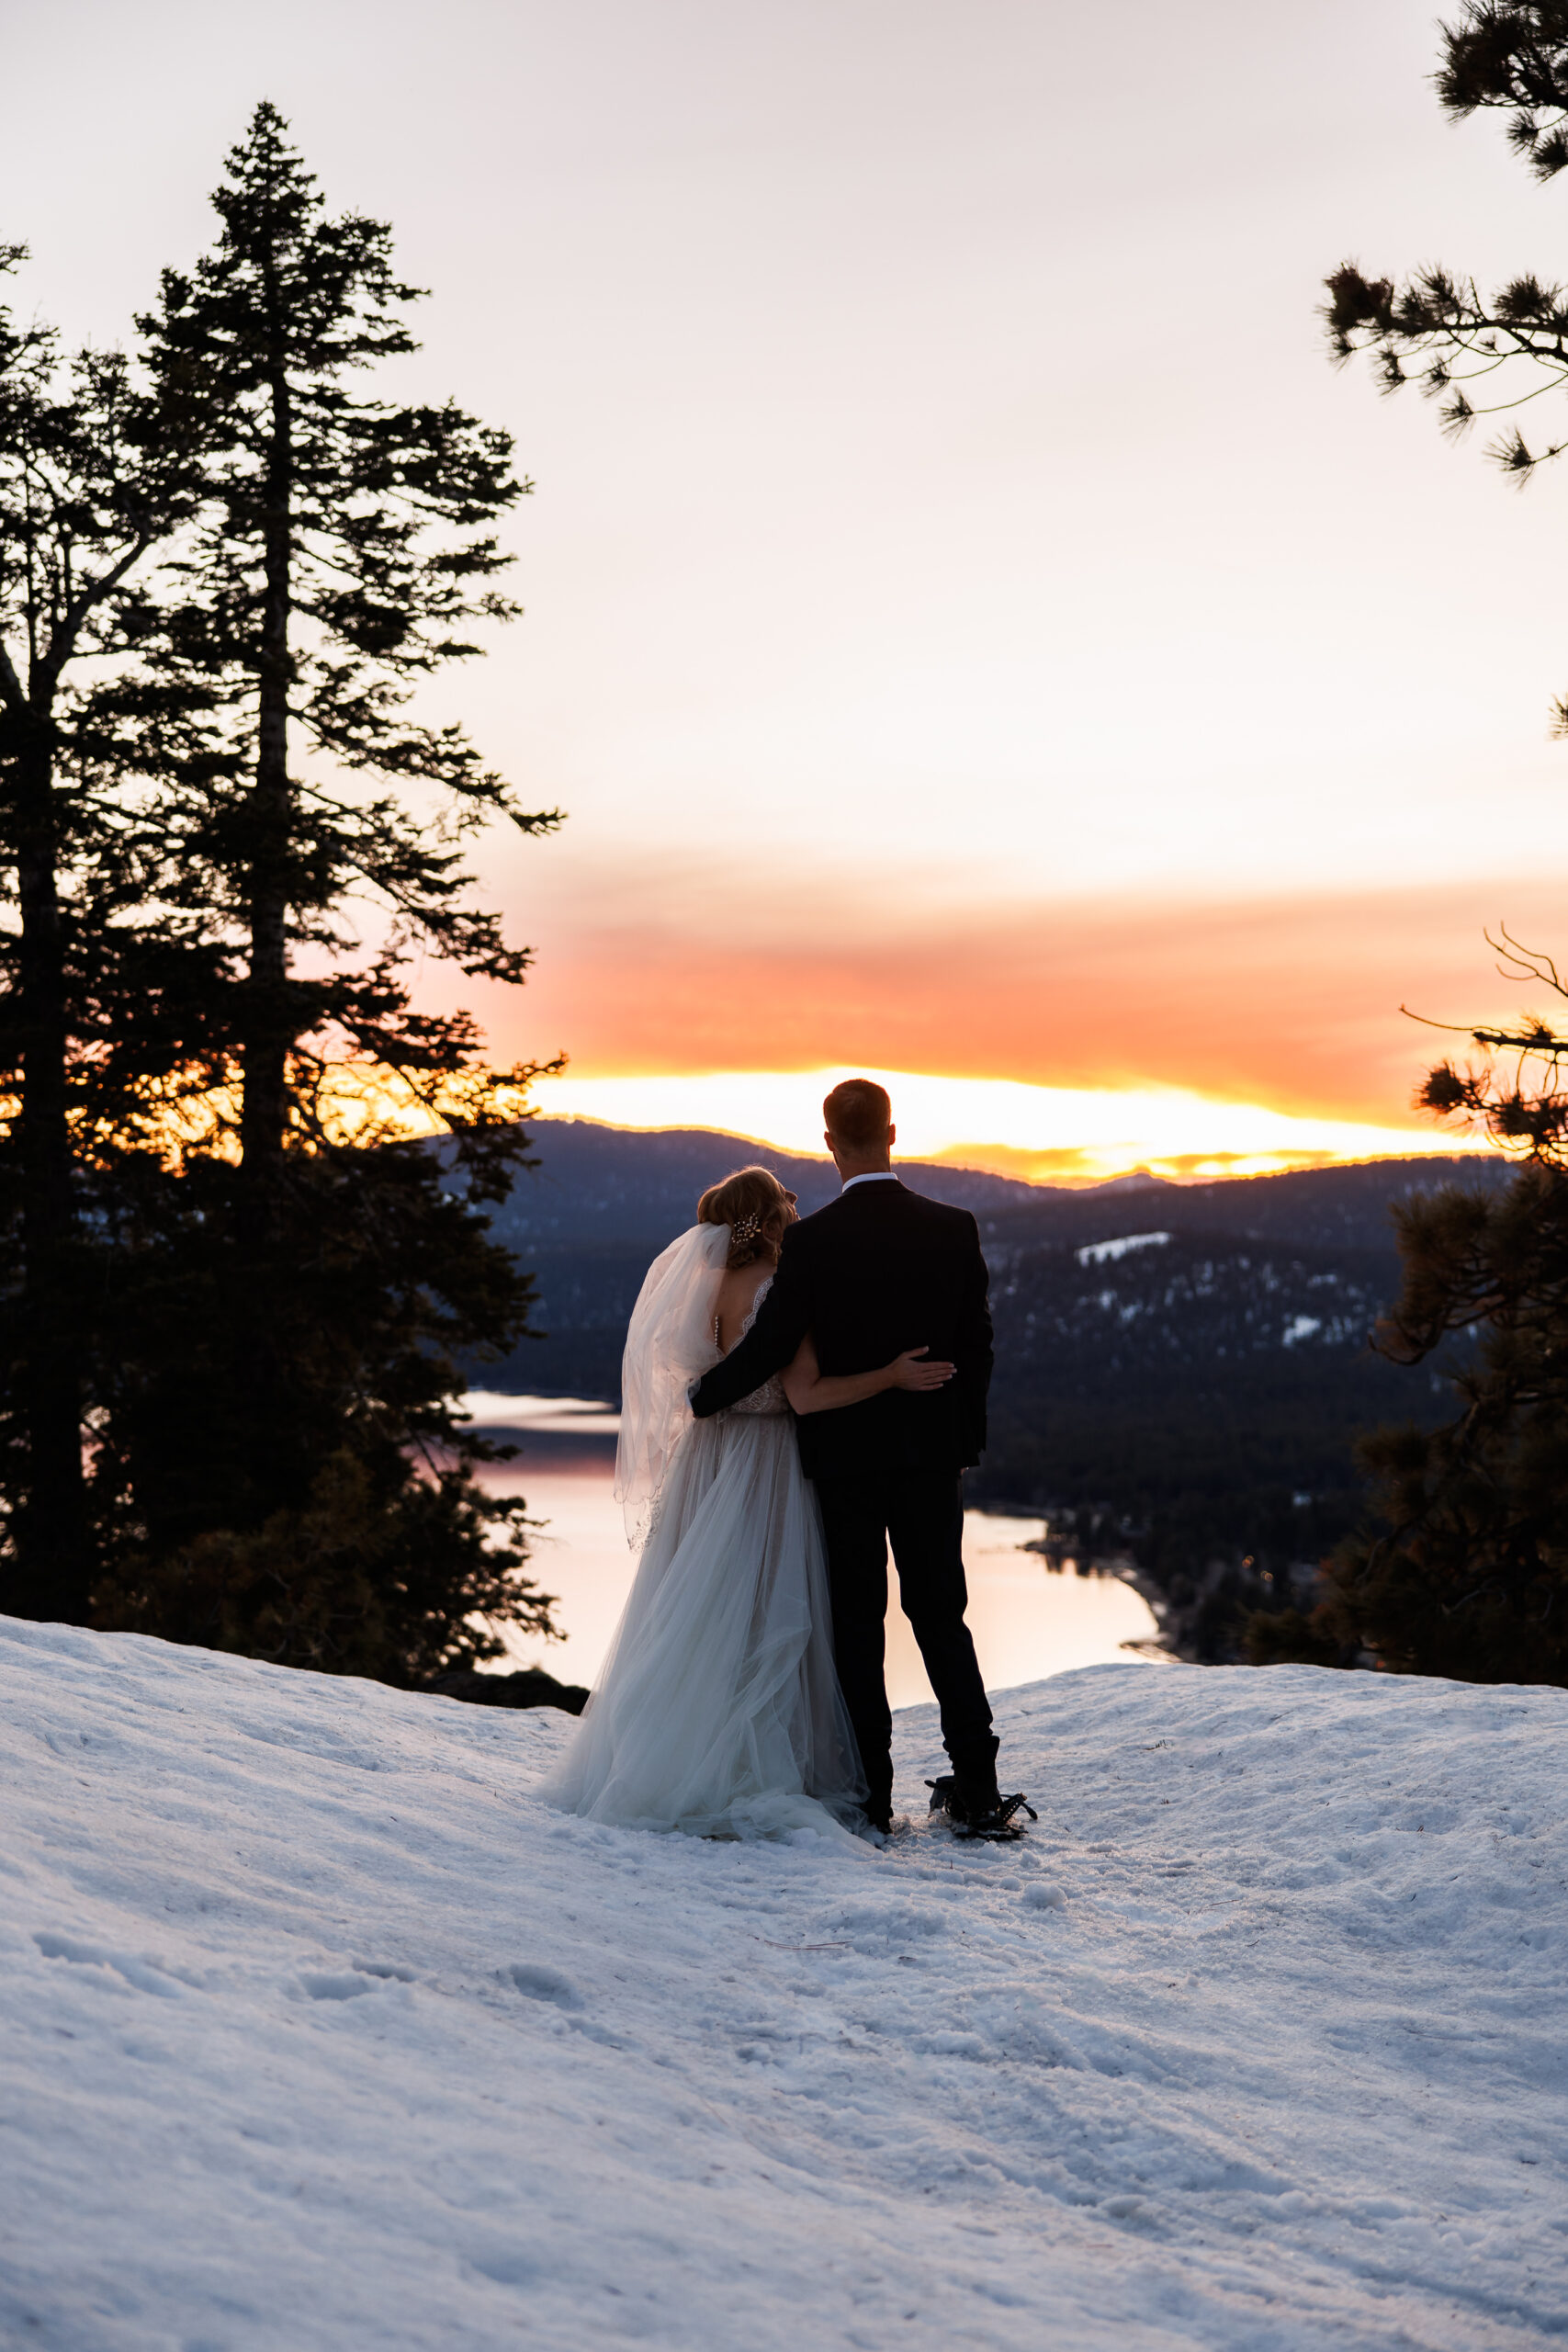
[0,104,559,1687]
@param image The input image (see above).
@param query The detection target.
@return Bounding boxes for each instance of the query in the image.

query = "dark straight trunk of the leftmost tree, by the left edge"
[7,713,92,1625]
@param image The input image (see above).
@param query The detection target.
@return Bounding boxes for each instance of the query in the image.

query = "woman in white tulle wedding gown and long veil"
[538,1169,952,1837]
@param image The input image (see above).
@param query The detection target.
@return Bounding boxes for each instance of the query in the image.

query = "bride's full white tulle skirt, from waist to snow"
[538,1411,865,1837]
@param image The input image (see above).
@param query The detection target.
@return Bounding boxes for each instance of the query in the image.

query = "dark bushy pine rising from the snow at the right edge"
[1248,932,1568,1684]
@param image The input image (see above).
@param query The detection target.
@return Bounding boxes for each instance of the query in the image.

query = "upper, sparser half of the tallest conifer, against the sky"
[141,104,559,1204]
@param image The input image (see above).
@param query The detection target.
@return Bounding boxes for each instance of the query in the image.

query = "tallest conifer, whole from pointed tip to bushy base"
[94,106,558,1681]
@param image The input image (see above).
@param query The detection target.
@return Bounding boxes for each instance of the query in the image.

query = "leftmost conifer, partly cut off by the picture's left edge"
[0,247,202,1623]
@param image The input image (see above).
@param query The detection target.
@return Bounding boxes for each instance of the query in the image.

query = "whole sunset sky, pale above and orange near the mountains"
[12,0,1568,1176]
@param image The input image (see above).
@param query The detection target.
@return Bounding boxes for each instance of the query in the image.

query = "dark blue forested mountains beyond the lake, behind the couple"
[479,1120,1509,1656]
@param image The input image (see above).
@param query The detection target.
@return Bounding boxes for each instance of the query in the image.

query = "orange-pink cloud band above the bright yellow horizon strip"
[469,868,1568,1122]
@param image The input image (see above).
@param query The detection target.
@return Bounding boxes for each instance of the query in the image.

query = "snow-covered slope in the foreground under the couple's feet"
[0,1621,1568,2352]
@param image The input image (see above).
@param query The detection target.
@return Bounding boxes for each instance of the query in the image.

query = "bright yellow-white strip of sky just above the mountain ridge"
[538,1068,1462,1183]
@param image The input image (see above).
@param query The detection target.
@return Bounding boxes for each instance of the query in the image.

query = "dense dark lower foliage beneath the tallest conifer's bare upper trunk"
[94,1143,555,1687]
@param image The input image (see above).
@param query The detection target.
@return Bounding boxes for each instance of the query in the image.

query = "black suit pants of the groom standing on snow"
[816,1470,997,1818]
